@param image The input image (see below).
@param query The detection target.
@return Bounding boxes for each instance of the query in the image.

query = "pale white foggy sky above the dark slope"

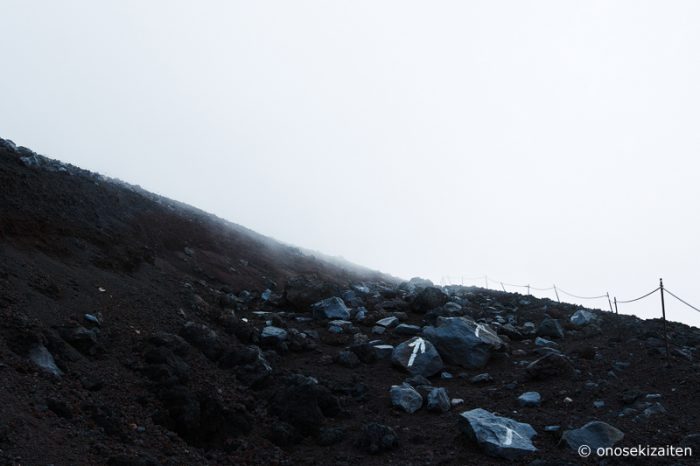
[0,0,700,325]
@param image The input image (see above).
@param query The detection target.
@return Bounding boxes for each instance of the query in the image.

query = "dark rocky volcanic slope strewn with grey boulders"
[0,140,700,466]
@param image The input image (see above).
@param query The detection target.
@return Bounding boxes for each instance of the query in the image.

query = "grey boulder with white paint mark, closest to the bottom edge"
[459,408,537,460]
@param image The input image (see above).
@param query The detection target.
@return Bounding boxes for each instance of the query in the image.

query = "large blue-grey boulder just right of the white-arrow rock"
[423,317,503,369]
